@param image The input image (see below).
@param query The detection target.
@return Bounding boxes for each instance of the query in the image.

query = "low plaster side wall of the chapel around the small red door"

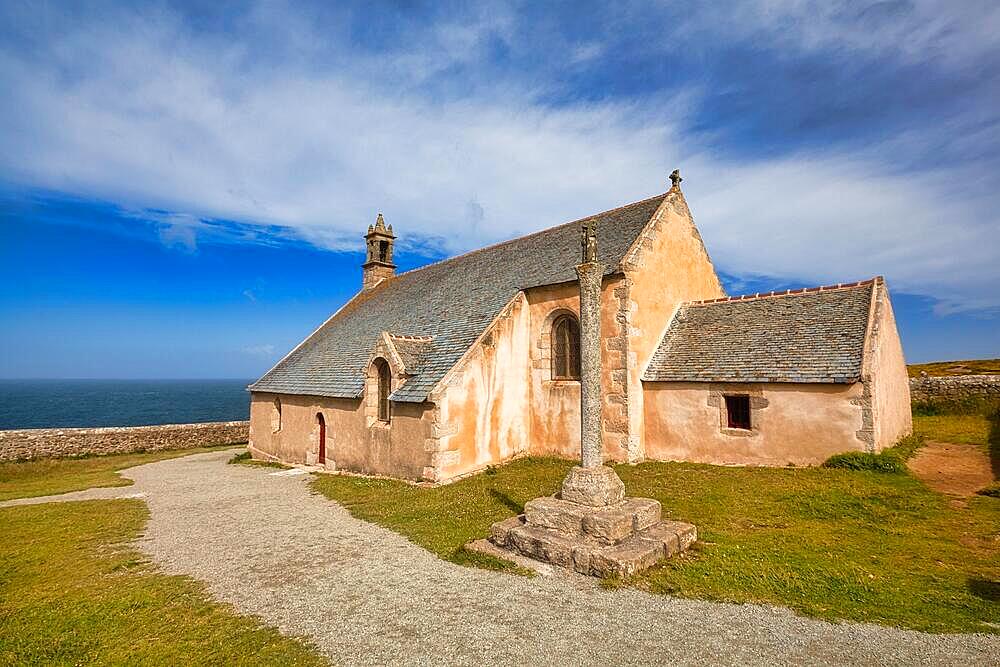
[250,392,433,480]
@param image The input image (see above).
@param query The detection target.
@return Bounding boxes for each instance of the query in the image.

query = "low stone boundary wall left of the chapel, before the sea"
[0,421,250,461]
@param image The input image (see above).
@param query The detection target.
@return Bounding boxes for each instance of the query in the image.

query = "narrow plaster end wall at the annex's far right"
[866,279,913,451]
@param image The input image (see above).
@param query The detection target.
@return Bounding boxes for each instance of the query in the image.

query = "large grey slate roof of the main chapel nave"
[249,194,667,402]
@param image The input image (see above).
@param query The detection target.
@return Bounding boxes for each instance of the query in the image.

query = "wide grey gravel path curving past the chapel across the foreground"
[115,452,1000,666]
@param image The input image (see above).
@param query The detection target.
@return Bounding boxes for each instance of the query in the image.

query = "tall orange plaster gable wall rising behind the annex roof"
[615,190,725,461]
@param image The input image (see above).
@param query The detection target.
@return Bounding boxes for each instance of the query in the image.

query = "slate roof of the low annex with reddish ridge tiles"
[642,279,877,383]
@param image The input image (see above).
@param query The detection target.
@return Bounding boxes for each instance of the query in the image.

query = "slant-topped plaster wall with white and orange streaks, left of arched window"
[434,295,531,481]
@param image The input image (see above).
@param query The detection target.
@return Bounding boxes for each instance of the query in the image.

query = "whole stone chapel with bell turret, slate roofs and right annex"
[249,172,911,483]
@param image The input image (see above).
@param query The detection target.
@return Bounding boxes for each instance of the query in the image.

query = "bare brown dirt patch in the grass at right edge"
[907,441,996,496]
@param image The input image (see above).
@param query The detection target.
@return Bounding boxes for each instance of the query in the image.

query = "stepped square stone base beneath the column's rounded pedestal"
[489,497,697,577]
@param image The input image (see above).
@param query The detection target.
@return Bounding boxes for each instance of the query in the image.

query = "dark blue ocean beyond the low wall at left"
[0,380,253,429]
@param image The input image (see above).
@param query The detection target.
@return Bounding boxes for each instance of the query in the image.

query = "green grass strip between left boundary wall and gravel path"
[0,445,242,500]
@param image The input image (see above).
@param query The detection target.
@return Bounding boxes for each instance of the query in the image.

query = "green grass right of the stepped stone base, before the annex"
[620,463,1000,632]
